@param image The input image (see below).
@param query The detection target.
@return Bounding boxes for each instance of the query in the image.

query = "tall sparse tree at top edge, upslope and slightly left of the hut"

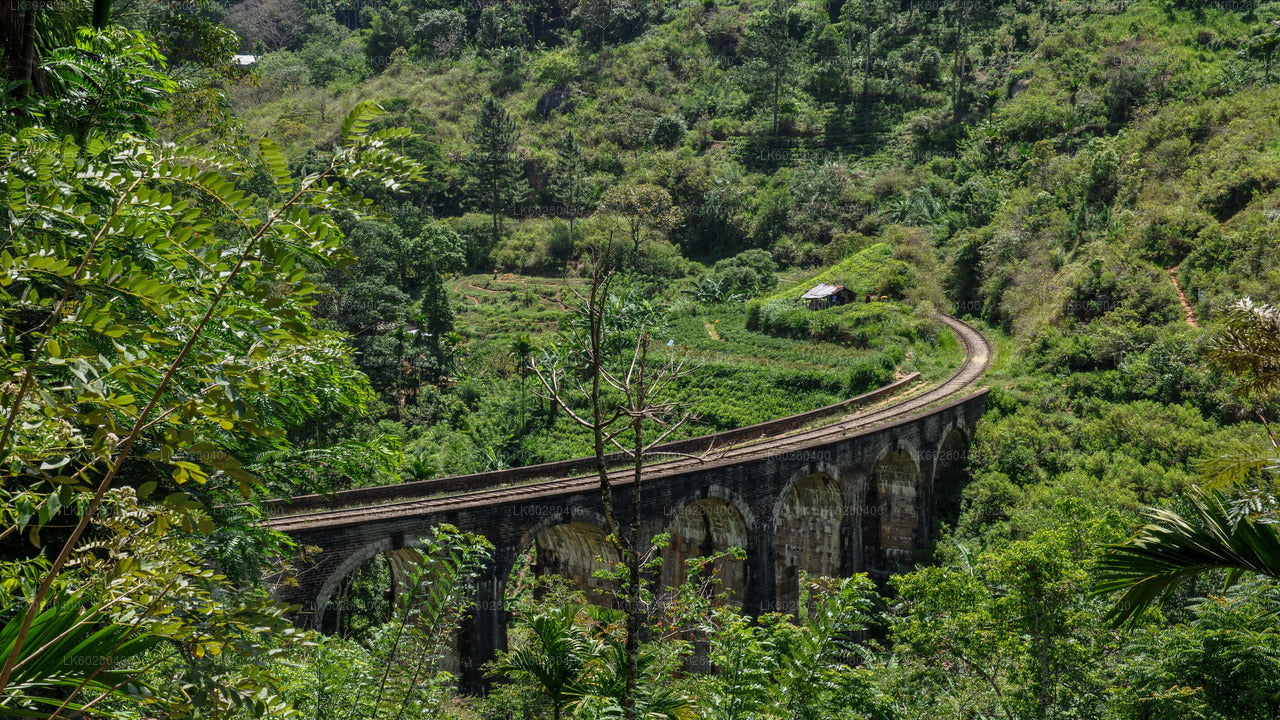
[739,0,803,135]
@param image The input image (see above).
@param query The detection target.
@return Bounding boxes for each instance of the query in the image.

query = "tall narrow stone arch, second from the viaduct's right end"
[863,447,922,574]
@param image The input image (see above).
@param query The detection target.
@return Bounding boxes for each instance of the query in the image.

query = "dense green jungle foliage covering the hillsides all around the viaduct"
[0,0,1280,720]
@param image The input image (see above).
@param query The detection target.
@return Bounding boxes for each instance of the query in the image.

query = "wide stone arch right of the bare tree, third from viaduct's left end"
[662,486,755,607]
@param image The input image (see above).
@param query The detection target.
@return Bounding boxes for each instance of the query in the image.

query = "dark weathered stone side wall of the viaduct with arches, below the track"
[272,391,987,688]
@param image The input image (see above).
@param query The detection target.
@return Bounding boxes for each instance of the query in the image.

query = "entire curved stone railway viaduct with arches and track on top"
[269,316,991,689]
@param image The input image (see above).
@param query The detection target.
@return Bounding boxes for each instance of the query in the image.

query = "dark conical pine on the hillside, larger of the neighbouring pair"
[466,95,529,242]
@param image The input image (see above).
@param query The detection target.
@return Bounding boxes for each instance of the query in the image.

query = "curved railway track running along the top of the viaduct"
[266,315,992,533]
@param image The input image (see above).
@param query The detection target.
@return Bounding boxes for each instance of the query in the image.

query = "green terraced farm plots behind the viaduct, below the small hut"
[452,274,963,464]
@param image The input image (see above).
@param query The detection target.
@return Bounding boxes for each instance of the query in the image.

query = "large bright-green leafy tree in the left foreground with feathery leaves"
[0,104,422,707]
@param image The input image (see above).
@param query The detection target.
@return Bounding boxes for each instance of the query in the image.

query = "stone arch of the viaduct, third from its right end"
[773,464,845,612]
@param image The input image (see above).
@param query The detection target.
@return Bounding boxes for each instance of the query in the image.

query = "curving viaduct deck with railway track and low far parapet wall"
[266,315,992,533]
